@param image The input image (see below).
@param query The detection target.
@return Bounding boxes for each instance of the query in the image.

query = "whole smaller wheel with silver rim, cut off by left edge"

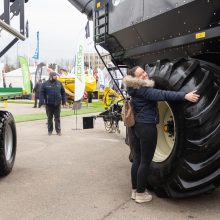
[0,111,17,176]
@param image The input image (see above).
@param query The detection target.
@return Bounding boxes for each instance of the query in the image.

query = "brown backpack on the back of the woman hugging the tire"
[121,99,135,128]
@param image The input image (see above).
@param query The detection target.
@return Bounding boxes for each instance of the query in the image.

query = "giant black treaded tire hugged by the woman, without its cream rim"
[131,59,220,198]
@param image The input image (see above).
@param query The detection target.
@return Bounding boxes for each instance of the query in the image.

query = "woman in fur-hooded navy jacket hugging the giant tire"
[123,66,200,203]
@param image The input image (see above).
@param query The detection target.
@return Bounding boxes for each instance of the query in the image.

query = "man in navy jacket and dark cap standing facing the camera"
[40,72,66,136]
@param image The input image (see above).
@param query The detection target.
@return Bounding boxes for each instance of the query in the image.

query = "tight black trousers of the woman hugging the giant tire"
[129,123,157,193]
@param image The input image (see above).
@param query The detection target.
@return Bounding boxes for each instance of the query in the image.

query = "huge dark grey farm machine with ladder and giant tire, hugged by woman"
[69,0,220,198]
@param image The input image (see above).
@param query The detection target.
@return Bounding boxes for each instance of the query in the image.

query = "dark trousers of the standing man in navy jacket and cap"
[46,105,61,133]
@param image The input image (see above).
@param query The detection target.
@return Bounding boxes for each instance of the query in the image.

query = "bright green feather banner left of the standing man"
[18,56,31,95]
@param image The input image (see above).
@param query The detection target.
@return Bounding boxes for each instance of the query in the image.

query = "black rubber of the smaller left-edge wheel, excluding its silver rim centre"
[0,112,17,176]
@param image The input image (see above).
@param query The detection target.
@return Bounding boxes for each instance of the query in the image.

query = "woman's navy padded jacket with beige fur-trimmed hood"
[123,76,186,124]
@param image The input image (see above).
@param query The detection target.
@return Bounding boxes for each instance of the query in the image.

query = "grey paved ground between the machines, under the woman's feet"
[0,107,220,220]
